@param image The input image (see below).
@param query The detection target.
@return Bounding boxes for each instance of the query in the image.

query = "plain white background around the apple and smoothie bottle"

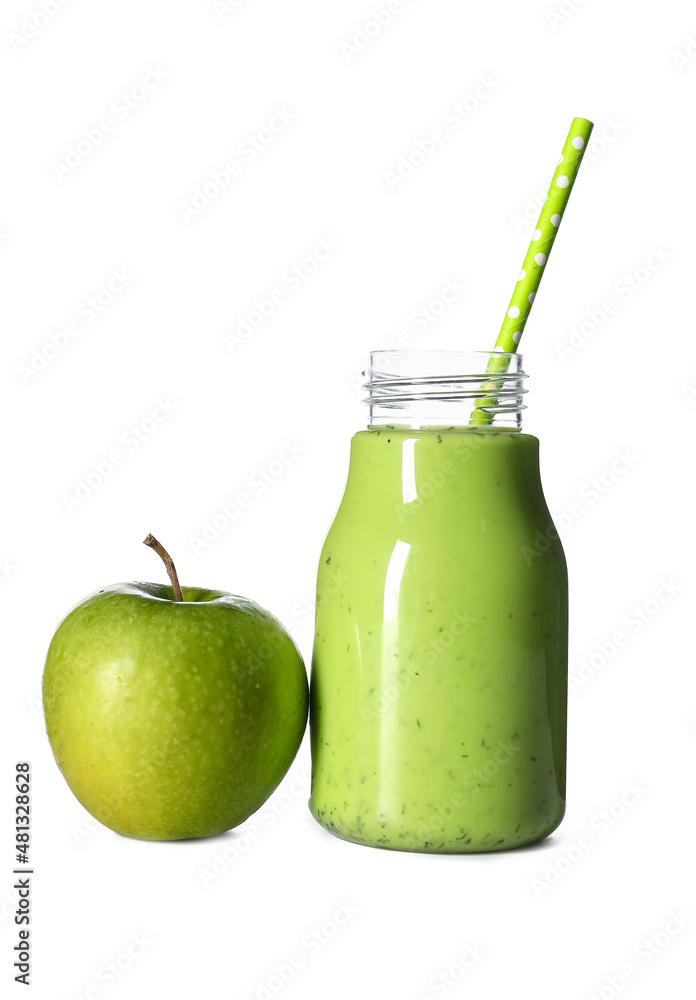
[0,0,696,1000]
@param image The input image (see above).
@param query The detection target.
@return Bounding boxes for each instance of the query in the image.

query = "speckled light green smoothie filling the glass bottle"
[310,427,567,853]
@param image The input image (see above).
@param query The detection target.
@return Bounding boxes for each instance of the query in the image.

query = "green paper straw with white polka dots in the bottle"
[469,118,594,424]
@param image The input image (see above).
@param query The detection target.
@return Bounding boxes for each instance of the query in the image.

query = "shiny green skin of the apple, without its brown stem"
[43,583,308,840]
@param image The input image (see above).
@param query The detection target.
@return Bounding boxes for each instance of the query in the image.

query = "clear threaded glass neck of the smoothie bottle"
[365,351,527,430]
